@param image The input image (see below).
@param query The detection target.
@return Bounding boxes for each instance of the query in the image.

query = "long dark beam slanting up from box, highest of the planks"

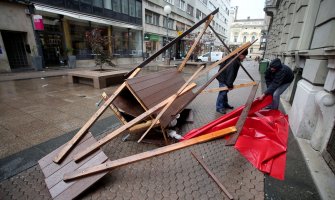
[128,8,219,74]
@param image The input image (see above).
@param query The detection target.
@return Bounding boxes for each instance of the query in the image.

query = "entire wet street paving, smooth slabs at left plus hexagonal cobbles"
[0,61,319,199]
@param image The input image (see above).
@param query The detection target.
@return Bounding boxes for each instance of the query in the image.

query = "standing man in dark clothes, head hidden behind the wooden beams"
[216,49,248,114]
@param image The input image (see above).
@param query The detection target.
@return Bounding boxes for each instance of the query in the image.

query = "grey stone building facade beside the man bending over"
[264,0,335,172]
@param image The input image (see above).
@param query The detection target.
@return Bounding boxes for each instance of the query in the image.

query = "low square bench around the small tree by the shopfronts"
[68,70,128,89]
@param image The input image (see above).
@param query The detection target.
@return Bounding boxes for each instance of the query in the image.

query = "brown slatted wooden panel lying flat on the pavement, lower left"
[38,133,108,199]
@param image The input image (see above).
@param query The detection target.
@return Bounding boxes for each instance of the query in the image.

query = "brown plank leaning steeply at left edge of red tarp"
[226,83,258,146]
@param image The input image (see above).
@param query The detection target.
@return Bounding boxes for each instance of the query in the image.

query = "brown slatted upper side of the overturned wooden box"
[127,69,185,108]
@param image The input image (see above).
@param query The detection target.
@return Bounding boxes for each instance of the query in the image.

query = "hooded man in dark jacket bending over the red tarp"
[260,58,294,110]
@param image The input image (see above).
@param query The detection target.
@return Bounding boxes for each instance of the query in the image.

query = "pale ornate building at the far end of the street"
[229,7,265,59]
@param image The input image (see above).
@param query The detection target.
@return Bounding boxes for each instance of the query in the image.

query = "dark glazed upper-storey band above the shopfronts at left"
[33,0,142,25]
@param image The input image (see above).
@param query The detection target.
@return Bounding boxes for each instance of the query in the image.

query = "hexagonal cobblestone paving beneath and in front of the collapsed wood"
[0,61,264,199]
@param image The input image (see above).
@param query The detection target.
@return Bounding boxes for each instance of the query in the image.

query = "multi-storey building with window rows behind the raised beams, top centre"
[143,0,230,59]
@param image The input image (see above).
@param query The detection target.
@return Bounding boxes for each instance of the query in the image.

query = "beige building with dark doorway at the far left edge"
[0,1,37,72]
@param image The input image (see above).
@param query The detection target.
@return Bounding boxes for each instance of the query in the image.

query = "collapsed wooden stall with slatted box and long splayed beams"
[40,9,254,198]
